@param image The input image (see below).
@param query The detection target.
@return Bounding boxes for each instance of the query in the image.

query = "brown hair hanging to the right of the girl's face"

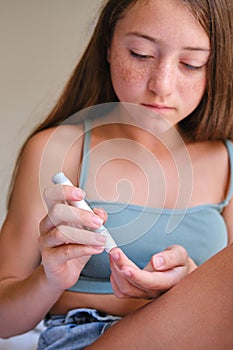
[180,0,233,141]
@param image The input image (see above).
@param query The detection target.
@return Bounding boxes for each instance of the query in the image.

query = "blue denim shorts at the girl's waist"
[38,308,120,350]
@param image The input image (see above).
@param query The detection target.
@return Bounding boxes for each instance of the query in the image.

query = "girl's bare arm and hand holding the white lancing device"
[0,130,105,338]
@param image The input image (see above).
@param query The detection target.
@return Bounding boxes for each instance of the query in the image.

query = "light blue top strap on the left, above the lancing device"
[79,119,91,190]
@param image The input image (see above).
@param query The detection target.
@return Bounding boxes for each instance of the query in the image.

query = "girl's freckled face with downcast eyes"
[108,0,210,125]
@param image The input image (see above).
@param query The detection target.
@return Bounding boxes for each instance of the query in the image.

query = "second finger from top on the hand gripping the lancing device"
[40,203,103,232]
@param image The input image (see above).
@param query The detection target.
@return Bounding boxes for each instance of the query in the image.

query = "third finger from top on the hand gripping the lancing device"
[40,225,106,249]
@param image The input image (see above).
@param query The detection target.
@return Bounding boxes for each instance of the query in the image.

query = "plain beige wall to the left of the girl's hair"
[0,0,104,224]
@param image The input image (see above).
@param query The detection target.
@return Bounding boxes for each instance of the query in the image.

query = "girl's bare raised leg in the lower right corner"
[88,244,233,350]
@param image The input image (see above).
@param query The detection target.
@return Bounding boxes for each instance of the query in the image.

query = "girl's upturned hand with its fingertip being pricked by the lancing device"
[109,245,196,299]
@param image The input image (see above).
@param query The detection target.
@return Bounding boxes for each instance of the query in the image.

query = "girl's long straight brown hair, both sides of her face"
[8,0,233,205]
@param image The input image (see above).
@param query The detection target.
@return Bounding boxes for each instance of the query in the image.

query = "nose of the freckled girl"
[147,63,176,97]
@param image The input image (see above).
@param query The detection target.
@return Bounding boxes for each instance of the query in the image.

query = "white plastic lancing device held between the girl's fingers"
[52,172,117,253]
